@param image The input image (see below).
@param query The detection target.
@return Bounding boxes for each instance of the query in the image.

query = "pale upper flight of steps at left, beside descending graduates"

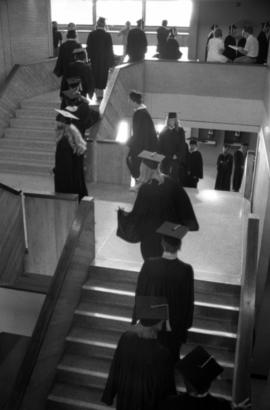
[0,92,60,176]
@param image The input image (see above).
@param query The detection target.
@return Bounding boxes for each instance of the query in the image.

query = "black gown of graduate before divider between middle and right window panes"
[127,28,147,62]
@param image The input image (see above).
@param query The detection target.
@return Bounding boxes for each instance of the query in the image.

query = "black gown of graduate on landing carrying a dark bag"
[131,176,199,259]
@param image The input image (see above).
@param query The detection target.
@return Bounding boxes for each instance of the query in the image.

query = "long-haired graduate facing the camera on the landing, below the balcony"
[158,112,187,185]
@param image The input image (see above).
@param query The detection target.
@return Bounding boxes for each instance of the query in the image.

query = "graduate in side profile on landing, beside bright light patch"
[127,91,158,179]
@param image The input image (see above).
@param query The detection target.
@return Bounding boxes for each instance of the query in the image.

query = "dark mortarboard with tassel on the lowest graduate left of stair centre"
[135,296,169,326]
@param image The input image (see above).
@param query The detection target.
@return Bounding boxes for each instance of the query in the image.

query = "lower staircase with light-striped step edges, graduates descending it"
[47,266,240,410]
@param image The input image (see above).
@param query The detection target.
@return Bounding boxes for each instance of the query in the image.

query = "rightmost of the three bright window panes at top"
[145,0,192,27]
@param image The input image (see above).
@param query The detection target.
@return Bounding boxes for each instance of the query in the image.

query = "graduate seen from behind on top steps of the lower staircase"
[132,222,194,362]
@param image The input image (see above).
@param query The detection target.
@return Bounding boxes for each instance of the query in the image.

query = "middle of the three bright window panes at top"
[97,0,142,25]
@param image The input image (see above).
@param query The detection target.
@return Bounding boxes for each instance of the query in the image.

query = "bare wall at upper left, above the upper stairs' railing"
[0,0,51,85]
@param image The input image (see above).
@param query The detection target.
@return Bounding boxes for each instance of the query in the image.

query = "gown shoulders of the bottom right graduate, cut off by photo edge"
[158,393,231,410]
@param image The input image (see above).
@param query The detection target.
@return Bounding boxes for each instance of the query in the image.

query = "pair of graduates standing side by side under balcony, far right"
[215,143,248,192]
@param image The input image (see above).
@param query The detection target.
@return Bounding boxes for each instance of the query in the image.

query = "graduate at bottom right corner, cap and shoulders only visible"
[158,346,251,410]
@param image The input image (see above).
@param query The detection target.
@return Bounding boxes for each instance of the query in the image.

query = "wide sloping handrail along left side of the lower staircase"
[6,198,93,410]
